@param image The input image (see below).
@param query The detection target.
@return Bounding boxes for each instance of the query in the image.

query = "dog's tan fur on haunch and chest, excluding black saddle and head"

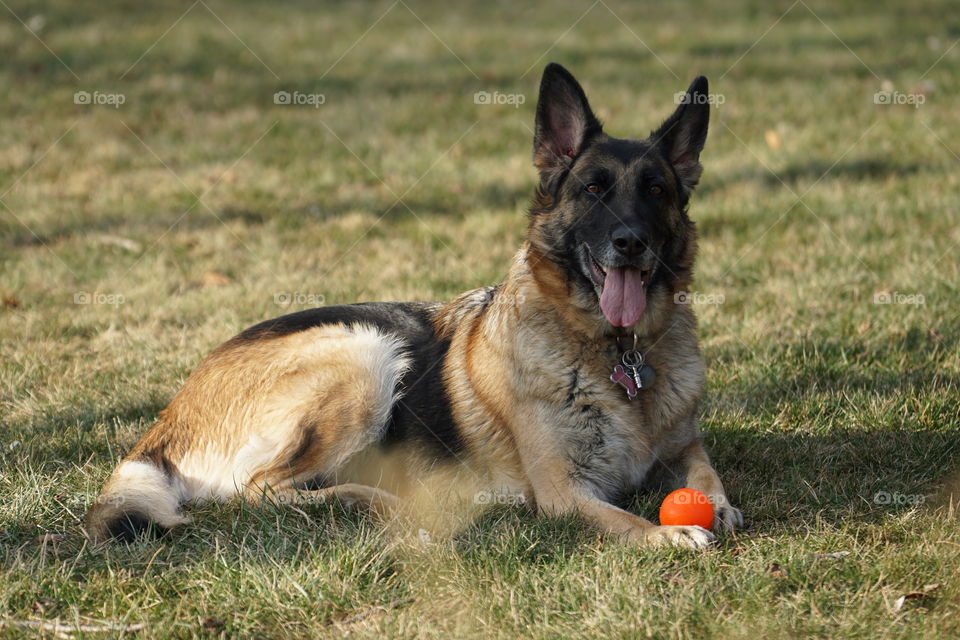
[90,240,738,546]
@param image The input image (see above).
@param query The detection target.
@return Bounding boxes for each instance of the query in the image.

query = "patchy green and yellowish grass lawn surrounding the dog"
[0,0,960,638]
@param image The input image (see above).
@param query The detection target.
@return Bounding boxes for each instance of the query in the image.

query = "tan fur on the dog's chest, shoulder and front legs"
[428,241,739,546]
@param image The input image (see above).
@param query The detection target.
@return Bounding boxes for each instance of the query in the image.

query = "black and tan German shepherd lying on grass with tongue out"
[86,64,742,548]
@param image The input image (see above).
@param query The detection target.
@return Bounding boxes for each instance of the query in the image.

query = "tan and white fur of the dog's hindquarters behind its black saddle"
[87,325,407,537]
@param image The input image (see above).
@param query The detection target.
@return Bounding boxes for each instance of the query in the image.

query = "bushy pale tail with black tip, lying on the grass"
[86,457,190,542]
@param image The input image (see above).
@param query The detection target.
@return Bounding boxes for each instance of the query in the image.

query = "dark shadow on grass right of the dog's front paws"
[706,427,960,532]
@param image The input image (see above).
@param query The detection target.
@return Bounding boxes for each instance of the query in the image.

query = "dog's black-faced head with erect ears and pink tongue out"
[529,64,710,333]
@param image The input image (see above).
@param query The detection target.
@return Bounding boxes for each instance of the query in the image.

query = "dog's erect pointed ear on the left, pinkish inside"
[533,62,601,177]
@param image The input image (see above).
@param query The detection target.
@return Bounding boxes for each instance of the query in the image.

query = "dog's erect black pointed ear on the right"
[650,76,710,195]
